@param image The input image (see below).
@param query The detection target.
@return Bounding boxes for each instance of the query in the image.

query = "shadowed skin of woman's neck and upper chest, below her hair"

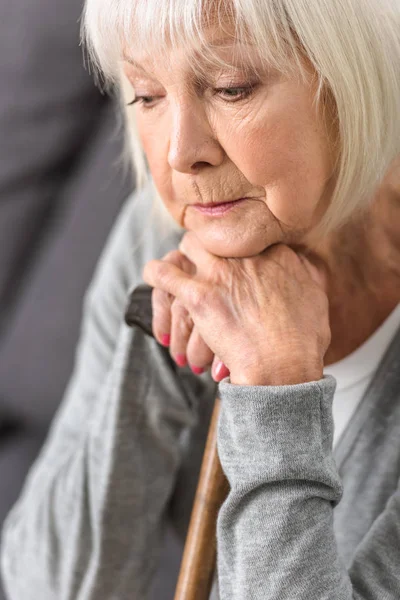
[316,179,400,365]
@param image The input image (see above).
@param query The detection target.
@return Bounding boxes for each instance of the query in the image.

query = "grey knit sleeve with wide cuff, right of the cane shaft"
[217,377,400,600]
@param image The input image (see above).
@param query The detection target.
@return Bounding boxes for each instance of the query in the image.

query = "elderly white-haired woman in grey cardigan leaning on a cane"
[2,0,400,600]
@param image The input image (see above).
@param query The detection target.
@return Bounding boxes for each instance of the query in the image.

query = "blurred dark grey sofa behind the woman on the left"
[0,0,183,600]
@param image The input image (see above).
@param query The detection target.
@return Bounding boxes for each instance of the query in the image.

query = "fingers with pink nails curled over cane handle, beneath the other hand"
[152,250,229,381]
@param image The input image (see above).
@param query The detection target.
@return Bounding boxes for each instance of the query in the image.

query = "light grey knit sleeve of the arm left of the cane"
[1,185,209,600]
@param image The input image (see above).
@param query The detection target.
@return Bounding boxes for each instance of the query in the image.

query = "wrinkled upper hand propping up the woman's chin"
[144,233,330,385]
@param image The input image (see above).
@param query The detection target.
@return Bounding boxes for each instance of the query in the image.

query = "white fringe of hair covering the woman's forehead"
[85,0,299,82]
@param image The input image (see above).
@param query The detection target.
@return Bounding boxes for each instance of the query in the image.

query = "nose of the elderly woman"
[168,99,224,174]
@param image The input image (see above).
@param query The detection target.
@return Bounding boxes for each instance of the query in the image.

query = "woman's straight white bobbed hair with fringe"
[83,0,400,231]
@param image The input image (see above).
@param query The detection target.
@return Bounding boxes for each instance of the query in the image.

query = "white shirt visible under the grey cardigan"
[324,304,400,447]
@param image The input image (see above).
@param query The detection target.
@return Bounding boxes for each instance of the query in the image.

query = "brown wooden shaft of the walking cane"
[174,398,229,600]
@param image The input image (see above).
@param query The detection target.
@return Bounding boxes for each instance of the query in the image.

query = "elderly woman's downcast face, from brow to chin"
[124,32,333,257]
